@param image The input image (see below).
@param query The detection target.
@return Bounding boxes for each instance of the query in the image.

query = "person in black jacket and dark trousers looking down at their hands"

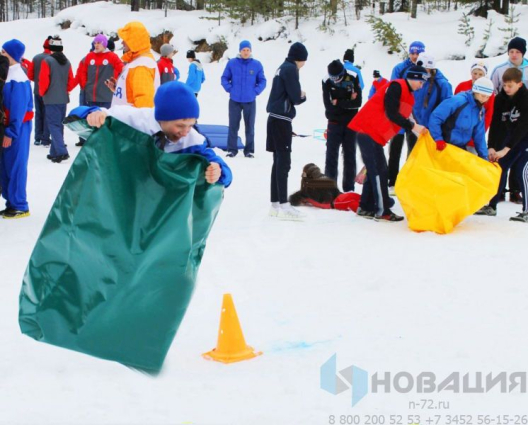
[323,60,362,192]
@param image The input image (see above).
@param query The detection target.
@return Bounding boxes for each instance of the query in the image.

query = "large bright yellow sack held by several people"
[395,133,501,234]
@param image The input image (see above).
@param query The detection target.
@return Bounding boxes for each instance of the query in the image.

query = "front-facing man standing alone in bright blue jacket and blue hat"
[221,40,266,158]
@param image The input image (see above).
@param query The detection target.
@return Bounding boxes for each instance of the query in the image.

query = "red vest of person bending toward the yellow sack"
[348,80,414,146]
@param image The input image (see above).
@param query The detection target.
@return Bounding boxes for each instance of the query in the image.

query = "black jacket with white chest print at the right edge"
[488,85,528,151]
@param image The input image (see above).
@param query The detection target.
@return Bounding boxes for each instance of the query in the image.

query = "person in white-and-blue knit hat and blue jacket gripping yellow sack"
[429,77,493,160]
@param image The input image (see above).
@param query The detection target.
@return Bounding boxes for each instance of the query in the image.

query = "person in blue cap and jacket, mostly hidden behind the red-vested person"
[389,41,425,195]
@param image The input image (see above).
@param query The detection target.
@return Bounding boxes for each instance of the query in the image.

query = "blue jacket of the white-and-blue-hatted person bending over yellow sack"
[429,91,488,159]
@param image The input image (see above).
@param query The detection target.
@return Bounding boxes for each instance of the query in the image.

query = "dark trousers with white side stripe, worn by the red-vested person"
[357,133,392,215]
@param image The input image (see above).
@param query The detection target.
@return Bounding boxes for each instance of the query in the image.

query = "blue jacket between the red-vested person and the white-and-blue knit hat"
[413,69,453,127]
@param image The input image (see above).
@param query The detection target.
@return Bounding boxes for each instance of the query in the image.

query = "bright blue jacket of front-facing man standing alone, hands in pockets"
[221,57,266,103]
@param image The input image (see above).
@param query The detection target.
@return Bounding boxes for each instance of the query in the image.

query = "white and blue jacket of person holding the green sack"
[70,105,233,187]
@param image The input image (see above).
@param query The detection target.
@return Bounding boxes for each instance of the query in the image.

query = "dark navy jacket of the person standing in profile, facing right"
[266,59,306,119]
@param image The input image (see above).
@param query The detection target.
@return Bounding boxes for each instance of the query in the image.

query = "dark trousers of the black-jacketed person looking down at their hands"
[325,121,356,192]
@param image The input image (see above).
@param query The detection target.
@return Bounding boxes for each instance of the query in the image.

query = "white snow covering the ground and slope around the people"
[0,3,528,425]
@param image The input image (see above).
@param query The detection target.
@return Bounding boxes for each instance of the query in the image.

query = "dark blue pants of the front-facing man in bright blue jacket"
[227,99,257,155]
